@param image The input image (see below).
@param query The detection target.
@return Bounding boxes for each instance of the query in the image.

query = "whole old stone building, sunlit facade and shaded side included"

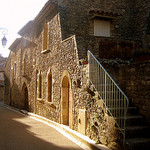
[5,0,150,149]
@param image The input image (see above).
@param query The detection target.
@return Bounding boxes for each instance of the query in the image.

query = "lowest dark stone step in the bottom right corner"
[126,138,150,150]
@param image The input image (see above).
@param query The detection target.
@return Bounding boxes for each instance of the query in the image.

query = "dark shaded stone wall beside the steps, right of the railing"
[122,61,150,123]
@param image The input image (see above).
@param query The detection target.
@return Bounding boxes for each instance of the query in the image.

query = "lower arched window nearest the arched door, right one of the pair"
[48,72,52,102]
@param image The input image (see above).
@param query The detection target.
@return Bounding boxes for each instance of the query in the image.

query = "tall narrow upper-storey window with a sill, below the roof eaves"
[43,20,48,50]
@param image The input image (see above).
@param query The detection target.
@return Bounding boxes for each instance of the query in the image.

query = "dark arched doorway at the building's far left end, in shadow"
[22,83,29,111]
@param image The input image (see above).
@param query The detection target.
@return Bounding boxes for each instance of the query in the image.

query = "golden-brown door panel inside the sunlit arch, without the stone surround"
[61,76,70,126]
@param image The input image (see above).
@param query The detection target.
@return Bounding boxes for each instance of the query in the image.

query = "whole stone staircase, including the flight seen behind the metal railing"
[88,51,150,150]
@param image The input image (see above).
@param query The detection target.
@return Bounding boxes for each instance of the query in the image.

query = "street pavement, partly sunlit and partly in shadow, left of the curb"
[0,105,81,150]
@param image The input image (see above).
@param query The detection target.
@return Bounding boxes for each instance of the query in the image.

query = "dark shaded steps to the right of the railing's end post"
[125,106,150,150]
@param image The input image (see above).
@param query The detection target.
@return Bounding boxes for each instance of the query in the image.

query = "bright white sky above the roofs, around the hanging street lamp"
[0,0,48,57]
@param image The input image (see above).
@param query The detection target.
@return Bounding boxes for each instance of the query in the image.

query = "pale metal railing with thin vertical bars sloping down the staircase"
[88,51,129,140]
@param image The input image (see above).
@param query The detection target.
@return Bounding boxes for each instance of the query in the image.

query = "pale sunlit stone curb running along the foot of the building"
[0,104,109,150]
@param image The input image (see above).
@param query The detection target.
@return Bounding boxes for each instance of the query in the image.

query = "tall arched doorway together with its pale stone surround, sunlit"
[61,71,72,128]
